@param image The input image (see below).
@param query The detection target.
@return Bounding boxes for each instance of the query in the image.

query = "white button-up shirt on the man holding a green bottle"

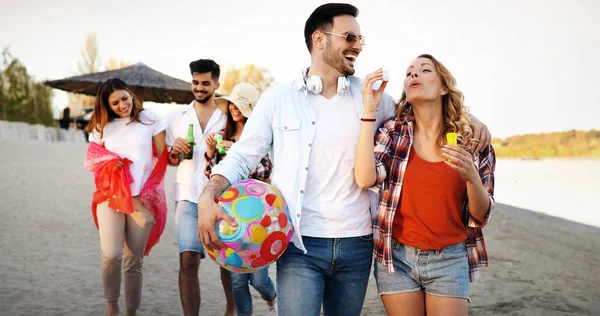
[166,101,227,203]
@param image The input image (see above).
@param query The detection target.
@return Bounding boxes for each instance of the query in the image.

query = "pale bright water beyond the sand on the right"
[495,158,600,227]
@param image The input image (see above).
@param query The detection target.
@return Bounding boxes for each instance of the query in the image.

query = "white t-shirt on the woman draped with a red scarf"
[89,110,167,196]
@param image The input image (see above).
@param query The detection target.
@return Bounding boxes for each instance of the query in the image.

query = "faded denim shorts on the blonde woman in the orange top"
[374,239,471,302]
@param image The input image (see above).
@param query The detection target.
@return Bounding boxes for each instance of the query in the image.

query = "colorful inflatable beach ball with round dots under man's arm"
[207,179,293,273]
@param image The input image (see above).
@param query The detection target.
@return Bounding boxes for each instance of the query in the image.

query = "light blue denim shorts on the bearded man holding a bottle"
[175,200,206,259]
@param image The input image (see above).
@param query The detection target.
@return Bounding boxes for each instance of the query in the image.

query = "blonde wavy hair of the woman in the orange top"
[396,54,478,150]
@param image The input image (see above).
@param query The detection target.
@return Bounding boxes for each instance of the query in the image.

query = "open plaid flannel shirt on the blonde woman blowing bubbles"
[373,117,496,282]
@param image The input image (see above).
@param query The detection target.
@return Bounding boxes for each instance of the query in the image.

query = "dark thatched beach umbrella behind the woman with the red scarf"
[44,63,194,104]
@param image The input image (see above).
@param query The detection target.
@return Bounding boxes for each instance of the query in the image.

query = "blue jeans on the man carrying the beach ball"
[277,235,373,316]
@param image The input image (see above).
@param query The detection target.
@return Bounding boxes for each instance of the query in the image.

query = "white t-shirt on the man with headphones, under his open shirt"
[300,91,372,238]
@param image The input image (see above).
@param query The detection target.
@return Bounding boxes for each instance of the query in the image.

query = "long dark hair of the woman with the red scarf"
[85,78,144,138]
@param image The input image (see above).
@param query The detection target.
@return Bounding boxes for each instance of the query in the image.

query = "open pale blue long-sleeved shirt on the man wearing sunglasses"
[212,76,395,252]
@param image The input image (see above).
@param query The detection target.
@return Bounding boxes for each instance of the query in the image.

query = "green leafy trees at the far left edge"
[0,48,54,126]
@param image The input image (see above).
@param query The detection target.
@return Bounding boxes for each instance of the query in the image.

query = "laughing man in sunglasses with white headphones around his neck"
[198,3,490,316]
